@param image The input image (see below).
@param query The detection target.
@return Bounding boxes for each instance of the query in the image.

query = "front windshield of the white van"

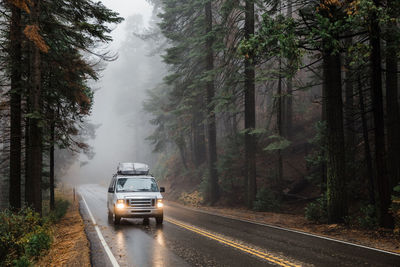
[117,178,159,192]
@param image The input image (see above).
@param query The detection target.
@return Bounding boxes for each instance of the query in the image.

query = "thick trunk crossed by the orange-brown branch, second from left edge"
[27,0,42,214]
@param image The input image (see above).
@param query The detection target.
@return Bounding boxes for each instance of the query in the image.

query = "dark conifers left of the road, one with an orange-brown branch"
[0,0,123,214]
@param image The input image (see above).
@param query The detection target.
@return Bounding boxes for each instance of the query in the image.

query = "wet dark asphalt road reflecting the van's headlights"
[79,185,400,267]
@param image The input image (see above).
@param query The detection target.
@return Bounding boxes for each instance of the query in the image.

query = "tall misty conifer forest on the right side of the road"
[144,0,400,228]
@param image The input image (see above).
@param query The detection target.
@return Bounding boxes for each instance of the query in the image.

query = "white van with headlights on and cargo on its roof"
[107,163,165,224]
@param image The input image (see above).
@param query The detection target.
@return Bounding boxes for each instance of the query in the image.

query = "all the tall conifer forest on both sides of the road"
[0,0,400,232]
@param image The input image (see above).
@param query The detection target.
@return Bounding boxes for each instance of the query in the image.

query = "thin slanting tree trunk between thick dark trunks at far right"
[357,77,375,205]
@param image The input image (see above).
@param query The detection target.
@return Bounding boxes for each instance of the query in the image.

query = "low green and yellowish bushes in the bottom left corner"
[0,200,69,267]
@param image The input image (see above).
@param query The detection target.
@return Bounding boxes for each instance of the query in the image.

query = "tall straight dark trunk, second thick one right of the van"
[244,0,257,208]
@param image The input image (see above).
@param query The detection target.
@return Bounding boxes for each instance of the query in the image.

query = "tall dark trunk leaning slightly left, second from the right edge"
[370,0,393,228]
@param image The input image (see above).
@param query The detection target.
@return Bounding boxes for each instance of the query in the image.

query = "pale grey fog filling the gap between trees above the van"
[61,0,165,183]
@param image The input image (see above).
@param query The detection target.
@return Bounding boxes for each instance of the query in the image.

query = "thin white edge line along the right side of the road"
[173,203,400,256]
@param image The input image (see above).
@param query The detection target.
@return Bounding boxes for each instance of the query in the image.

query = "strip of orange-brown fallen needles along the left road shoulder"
[36,200,91,267]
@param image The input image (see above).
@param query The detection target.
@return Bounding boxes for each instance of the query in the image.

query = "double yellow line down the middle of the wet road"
[165,218,301,267]
